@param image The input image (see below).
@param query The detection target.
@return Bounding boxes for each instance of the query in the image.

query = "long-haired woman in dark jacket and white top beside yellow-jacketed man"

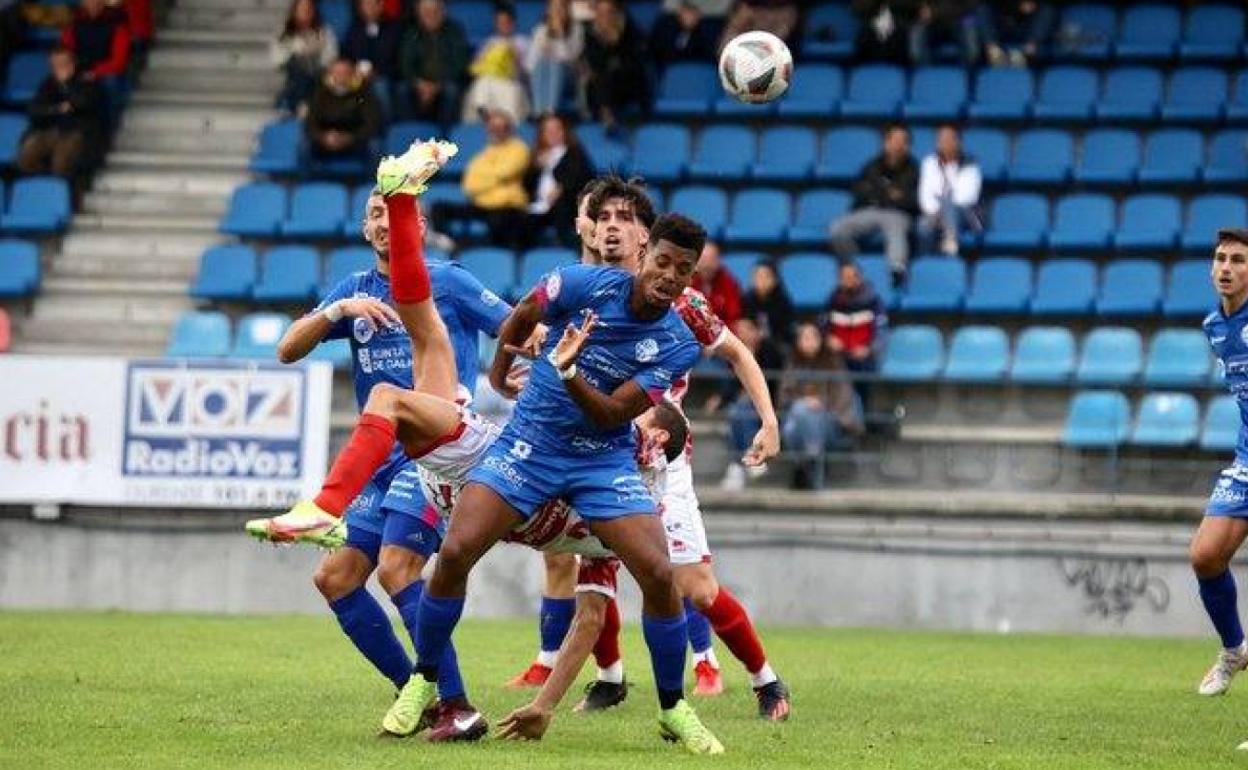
[524,115,594,248]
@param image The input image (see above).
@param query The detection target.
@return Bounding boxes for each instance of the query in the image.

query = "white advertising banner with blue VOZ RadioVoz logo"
[0,356,333,508]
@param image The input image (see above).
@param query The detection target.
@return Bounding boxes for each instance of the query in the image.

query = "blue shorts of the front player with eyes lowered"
[467,426,655,520]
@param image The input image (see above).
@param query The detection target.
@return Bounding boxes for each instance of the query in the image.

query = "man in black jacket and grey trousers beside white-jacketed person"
[831,125,919,286]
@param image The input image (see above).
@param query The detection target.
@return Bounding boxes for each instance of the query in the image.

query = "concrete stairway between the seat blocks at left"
[14,0,287,356]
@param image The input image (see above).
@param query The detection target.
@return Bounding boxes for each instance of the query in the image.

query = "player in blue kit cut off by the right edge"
[1191,228,1248,695]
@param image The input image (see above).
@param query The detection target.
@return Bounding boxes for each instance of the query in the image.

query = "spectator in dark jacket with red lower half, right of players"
[826,262,889,409]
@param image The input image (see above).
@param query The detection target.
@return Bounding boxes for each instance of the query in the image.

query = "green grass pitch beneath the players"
[0,613,1248,770]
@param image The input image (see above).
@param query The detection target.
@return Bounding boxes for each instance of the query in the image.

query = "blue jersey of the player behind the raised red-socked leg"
[317,262,512,408]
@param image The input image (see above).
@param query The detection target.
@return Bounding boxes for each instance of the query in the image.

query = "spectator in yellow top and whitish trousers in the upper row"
[462,5,529,124]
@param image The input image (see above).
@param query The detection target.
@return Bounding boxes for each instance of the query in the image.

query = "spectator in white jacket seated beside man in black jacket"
[917,124,983,256]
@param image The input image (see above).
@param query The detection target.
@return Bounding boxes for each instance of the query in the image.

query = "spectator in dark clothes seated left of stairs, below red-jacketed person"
[17,47,102,180]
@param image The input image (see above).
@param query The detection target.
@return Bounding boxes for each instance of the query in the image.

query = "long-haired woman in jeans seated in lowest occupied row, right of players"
[780,323,864,489]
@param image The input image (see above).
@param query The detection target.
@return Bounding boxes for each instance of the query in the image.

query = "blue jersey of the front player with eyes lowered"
[510,265,701,453]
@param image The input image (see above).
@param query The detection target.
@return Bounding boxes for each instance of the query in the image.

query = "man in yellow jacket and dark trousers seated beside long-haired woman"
[431,107,529,250]
